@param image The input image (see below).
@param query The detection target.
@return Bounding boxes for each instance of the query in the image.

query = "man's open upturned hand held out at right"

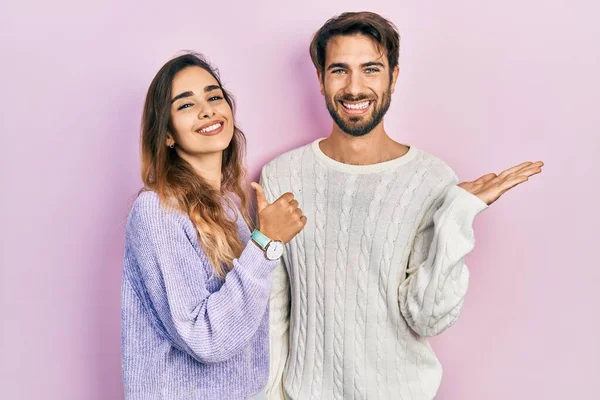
[458,161,544,205]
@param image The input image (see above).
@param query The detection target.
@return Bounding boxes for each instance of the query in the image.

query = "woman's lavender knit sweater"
[122,191,277,400]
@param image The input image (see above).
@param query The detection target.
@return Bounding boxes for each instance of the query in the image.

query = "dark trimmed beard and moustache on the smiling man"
[325,88,392,137]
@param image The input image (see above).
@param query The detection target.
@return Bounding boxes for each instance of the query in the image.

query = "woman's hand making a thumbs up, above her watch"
[252,182,306,243]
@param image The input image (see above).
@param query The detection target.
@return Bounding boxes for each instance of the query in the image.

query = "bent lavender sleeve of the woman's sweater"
[127,194,276,364]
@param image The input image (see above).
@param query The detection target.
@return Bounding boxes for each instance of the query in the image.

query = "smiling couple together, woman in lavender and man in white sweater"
[122,12,542,400]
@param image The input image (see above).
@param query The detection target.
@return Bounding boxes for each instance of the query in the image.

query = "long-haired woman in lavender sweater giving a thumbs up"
[122,53,306,400]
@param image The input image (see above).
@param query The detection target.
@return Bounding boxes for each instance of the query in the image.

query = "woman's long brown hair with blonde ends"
[141,53,252,277]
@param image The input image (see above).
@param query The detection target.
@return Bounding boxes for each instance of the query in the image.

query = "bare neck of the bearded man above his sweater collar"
[319,123,408,165]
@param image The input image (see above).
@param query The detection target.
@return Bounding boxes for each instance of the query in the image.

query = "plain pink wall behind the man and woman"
[0,0,600,400]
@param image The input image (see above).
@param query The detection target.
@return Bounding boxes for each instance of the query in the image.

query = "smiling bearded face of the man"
[318,34,398,136]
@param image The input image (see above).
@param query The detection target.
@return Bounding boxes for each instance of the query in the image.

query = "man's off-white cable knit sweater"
[261,139,487,400]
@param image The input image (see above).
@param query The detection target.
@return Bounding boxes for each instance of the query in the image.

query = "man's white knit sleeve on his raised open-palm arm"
[399,185,487,336]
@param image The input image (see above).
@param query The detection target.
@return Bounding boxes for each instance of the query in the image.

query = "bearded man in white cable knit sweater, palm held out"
[258,12,543,400]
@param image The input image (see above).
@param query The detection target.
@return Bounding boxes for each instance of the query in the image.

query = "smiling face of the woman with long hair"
[166,66,234,159]
